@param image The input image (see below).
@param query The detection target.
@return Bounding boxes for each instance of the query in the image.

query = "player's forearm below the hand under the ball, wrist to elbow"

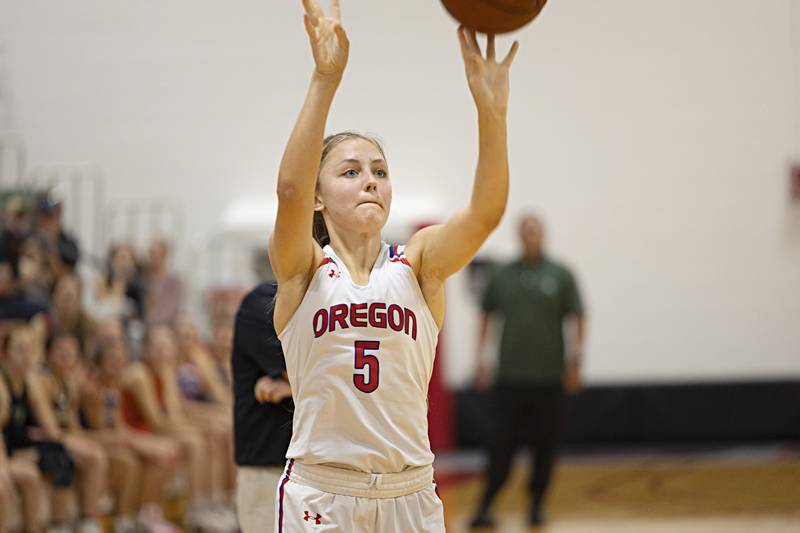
[469,109,508,229]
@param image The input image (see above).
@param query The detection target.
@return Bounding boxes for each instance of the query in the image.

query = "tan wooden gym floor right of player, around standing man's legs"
[436,445,800,533]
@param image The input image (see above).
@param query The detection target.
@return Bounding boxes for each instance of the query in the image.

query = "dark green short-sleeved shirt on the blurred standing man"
[482,257,583,384]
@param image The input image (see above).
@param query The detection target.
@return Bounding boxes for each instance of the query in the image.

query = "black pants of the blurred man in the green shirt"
[480,384,564,513]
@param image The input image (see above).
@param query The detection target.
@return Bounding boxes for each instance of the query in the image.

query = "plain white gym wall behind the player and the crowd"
[0,0,800,383]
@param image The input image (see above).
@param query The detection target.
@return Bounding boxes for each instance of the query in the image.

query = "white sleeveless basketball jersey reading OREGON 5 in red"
[280,243,438,473]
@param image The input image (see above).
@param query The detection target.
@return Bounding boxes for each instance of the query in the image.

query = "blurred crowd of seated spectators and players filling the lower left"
[0,192,237,533]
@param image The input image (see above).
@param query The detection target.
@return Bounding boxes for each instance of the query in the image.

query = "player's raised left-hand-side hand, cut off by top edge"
[303,0,350,79]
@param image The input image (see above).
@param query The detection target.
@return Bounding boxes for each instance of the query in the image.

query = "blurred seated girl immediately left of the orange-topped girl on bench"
[83,336,180,533]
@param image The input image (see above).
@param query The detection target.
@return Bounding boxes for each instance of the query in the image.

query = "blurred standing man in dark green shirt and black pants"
[472,215,586,527]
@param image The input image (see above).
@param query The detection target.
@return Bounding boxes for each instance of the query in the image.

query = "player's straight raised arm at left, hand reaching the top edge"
[269,0,350,283]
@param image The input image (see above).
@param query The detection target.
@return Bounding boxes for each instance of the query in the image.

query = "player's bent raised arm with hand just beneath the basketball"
[406,27,519,286]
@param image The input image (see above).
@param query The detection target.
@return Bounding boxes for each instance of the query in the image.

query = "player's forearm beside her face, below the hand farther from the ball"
[278,72,339,198]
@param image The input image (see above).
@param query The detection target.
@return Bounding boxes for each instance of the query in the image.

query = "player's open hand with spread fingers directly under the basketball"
[458,26,519,115]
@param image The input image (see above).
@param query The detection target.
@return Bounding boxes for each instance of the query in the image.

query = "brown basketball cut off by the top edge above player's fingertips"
[442,0,547,33]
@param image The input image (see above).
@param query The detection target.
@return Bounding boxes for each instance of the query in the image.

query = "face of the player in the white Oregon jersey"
[315,139,392,234]
